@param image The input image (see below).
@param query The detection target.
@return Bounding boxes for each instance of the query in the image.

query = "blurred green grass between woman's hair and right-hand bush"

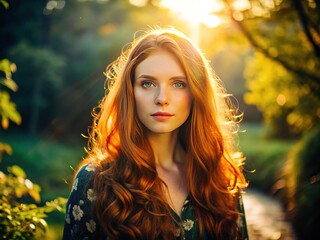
[239,124,295,193]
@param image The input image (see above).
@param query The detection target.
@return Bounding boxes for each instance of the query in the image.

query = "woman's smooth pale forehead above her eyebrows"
[135,50,185,76]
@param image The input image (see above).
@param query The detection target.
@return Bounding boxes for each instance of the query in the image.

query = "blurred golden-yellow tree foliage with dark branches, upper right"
[229,0,320,138]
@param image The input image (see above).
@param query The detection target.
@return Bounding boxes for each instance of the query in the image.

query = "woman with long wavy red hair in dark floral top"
[64,29,247,239]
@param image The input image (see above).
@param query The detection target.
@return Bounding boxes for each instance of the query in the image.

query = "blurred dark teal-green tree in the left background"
[9,42,65,134]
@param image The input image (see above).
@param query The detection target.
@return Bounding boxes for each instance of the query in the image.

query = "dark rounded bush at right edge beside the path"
[285,128,320,239]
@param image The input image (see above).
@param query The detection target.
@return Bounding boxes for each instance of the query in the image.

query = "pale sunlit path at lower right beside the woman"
[243,190,296,240]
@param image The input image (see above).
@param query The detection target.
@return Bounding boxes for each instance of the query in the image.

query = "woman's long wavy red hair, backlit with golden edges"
[80,29,246,239]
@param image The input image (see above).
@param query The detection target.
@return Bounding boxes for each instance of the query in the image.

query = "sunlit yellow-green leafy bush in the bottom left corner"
[0,165,66,240]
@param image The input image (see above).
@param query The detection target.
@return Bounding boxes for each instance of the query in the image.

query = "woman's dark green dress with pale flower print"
[63,164,248,240]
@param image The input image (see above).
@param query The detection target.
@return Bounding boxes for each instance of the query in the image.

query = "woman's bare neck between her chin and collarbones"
[148,131,184,168]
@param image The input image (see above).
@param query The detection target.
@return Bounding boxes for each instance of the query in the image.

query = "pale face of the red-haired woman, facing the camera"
[134,51,192,133]
